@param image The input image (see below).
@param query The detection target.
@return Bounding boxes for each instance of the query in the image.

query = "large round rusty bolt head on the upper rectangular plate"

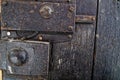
[40,5,54,18]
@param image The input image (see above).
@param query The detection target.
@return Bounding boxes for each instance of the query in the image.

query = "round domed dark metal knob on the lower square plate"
[8,48,28,66]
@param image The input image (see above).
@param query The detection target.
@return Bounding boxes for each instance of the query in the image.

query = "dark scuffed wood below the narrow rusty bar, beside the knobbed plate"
[52,24,95,80]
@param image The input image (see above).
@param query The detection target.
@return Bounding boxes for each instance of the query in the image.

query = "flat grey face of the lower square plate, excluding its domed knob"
[0,41,49,76]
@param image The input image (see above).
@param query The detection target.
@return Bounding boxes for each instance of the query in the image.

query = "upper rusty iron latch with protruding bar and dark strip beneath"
[1,0,95,42]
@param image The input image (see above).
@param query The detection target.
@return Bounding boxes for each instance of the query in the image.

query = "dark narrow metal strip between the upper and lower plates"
[1,31,73,43]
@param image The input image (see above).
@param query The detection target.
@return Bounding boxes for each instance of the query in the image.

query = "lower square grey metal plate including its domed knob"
[0,40,50,76]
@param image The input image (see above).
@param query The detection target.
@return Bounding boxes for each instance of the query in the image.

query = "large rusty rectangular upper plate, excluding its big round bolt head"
[1,0,75,32]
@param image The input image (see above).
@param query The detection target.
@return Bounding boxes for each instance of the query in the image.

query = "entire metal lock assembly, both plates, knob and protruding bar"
[0,0,95,79]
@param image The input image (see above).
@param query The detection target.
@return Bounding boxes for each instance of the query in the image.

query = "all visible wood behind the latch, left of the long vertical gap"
[1,0,97,80]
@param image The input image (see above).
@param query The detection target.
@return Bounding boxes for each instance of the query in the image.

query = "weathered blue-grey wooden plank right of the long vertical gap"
[93,0,120,80]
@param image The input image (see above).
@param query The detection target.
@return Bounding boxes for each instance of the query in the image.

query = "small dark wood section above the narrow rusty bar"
[76,0,97,15]
